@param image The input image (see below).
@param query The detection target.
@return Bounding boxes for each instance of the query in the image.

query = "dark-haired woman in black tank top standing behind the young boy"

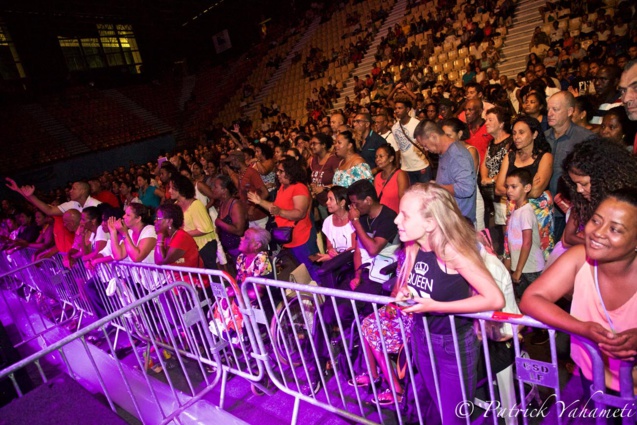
[495,115,555,259]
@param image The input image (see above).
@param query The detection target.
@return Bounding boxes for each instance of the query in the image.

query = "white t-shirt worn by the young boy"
[507,203,544,273]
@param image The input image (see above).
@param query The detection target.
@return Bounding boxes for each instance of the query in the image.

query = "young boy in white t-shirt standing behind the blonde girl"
[505,169,544,299]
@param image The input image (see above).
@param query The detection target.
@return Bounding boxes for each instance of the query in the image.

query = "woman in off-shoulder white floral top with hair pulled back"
[332,131,374,188]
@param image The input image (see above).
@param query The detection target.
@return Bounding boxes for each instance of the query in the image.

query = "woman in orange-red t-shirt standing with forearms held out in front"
[248,157,318,280]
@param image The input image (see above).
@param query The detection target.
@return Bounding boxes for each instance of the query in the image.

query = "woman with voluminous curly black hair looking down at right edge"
[561,139,637,248]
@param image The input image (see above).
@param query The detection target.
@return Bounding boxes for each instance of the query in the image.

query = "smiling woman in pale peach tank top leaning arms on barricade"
[520,188,637,394]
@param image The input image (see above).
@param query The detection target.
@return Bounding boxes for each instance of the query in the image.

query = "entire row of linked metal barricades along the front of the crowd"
[0,247,633,424]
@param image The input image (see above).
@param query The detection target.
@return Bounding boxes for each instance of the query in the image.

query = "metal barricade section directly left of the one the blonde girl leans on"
[87,262,269,408]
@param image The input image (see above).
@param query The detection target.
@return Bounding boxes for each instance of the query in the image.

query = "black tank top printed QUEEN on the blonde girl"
[408,250,473,335]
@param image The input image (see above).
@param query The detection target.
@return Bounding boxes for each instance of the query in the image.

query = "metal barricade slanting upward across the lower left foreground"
[0,282,221,424]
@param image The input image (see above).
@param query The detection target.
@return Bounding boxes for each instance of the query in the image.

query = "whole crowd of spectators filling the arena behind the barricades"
[1,2,637,423]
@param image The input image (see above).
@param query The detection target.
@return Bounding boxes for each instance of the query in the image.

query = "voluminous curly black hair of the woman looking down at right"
[562,138,637,227]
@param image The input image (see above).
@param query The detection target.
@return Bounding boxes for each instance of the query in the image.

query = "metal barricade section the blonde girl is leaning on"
[242,278,561,424]
